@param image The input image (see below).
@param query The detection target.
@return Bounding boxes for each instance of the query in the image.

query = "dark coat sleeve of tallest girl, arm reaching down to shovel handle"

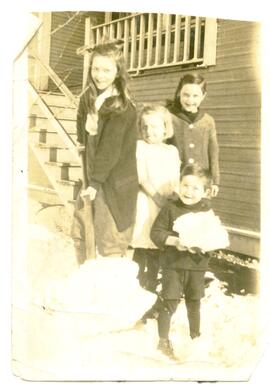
[89,110,136,189]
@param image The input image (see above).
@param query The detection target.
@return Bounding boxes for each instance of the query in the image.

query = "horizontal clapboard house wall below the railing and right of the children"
[131,20,261,231]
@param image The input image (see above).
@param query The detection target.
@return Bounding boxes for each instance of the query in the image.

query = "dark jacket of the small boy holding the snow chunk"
[150,199,211,271]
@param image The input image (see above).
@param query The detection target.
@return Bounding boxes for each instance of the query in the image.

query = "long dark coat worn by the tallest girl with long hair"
[77,97,138,231]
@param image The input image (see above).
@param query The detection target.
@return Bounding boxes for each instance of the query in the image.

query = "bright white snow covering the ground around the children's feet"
[13,201,260,380]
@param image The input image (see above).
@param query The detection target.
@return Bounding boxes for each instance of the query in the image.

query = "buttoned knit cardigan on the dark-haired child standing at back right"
[168,109,220,184]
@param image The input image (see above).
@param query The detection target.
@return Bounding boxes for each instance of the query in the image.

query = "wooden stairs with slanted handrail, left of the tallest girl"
[28,85,82,211]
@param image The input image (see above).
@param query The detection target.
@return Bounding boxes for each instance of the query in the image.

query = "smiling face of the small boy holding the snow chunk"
[179,175,207,205]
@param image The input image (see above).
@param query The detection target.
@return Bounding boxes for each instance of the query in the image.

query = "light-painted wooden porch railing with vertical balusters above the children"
[80,13,217,77]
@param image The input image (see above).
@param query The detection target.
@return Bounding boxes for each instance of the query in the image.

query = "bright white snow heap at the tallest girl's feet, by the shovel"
[39,258,155,326]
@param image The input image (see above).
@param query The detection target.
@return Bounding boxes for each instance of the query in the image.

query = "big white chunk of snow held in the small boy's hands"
[173,210,229,252]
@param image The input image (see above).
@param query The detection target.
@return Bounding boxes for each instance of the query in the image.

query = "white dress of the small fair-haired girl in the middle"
[131,140,181,249]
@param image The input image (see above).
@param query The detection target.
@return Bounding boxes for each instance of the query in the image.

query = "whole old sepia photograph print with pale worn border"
[4,0,269,382]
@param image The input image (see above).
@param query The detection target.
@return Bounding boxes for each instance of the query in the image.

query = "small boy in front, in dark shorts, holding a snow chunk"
[150,164,228,358]
